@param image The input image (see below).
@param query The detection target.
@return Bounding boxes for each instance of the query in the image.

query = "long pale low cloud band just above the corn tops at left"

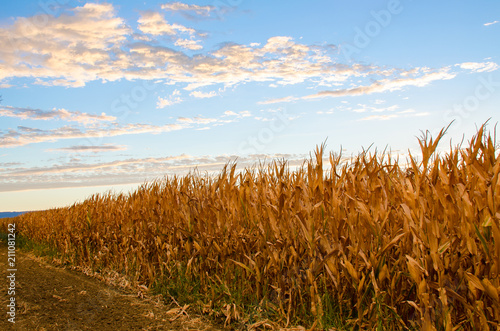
[0,152,307,192]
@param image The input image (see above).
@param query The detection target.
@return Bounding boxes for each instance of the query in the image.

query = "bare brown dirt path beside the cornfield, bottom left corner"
[0,243,223,330]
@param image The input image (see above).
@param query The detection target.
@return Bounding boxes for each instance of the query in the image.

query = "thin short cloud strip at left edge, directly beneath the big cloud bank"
[0,106,116,124]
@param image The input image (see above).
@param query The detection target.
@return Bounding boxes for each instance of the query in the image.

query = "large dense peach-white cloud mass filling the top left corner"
[0,3,131,86]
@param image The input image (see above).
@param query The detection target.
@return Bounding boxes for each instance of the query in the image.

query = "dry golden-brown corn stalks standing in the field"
[1,126,500,330]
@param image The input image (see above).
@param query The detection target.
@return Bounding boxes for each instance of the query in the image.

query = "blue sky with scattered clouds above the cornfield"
[0,0,500,211]
